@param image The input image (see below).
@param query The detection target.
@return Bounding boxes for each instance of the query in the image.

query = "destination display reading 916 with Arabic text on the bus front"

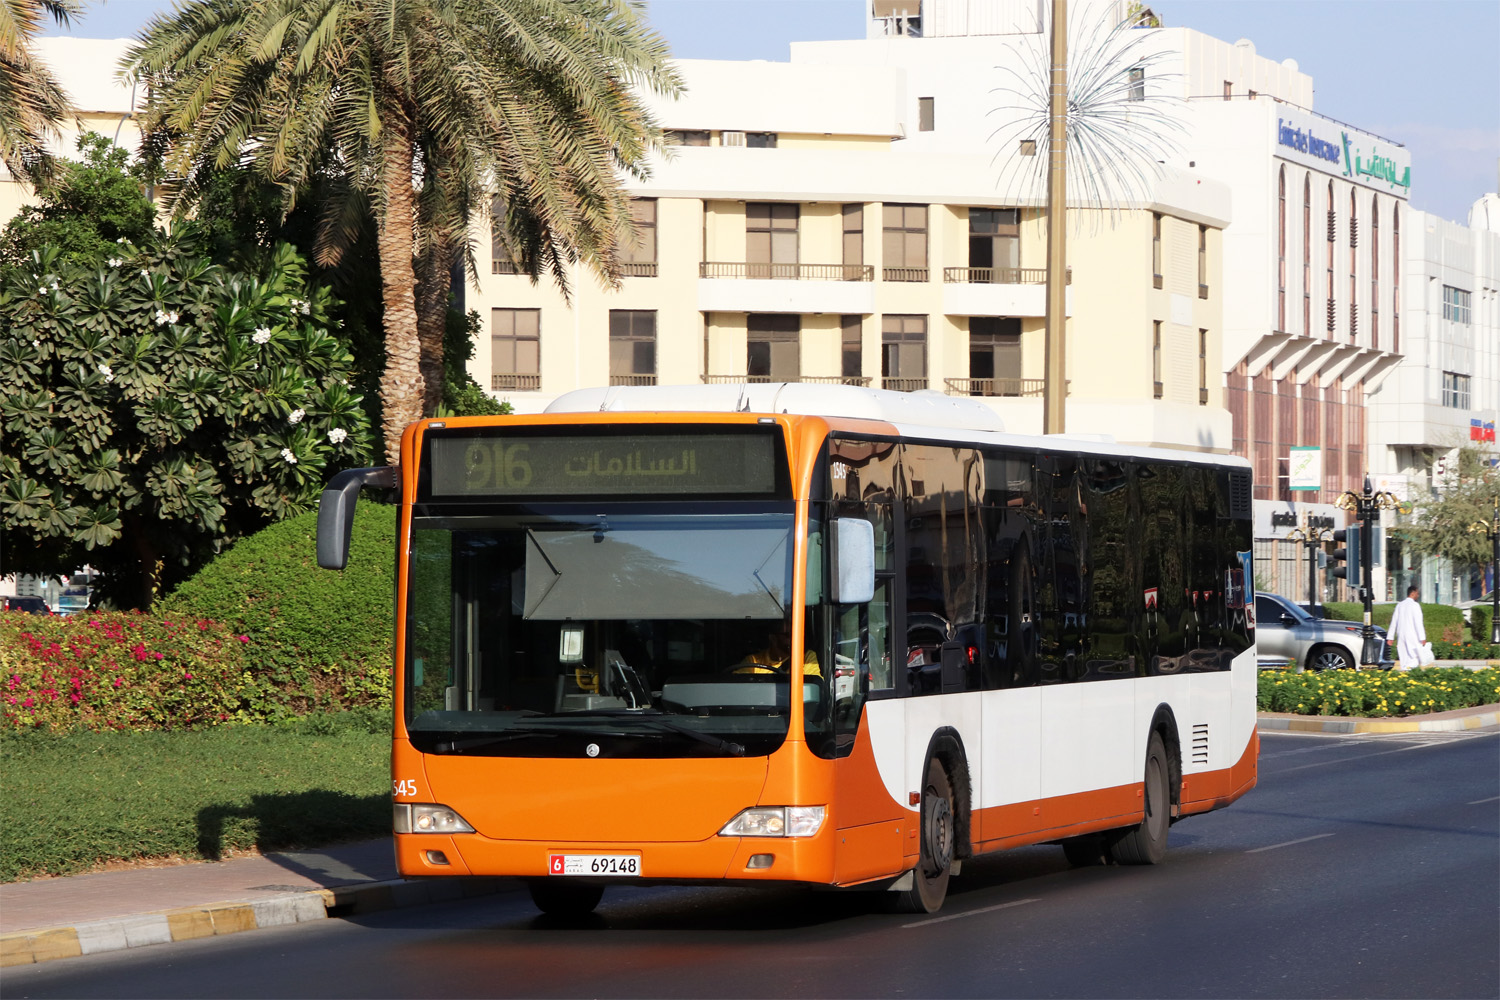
[429,433,777,498]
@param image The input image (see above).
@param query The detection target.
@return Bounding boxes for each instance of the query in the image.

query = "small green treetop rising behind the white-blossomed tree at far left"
[0,132,156,267]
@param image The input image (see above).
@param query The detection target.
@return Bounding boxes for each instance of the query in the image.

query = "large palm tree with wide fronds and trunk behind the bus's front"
[125,0,680,462]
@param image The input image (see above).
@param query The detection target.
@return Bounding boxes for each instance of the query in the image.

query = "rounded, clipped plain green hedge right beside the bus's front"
[161,498,396,692]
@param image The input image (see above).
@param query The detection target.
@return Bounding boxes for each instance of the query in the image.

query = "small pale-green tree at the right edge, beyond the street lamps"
[1395,445,1500,567]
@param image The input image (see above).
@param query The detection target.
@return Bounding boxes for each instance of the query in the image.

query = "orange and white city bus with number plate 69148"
[318,384,1259,915]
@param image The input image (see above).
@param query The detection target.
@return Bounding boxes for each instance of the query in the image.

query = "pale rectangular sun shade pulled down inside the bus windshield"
[525,519,792,621]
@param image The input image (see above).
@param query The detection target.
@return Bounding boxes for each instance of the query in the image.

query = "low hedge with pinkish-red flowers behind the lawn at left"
[0,613,390,732]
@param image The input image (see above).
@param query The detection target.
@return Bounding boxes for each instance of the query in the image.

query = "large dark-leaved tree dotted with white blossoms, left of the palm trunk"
[0,233,369,607]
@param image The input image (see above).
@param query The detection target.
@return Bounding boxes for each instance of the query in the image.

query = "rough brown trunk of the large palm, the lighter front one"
[375,106,423,465]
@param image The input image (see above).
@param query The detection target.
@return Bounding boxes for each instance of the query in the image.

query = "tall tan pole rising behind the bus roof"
[1041,0,1068,433]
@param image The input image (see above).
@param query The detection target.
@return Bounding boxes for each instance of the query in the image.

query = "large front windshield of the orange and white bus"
[405,504,819,757]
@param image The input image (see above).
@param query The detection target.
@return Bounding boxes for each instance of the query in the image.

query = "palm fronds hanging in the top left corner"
[0,0,80,184]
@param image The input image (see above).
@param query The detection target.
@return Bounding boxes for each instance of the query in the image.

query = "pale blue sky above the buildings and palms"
[48,0,1500,222]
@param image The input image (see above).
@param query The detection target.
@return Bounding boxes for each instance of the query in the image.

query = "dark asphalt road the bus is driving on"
[3,732,1500,1000]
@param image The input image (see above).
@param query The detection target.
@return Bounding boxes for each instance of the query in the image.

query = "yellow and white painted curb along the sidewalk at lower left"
[0,877,519,969]
